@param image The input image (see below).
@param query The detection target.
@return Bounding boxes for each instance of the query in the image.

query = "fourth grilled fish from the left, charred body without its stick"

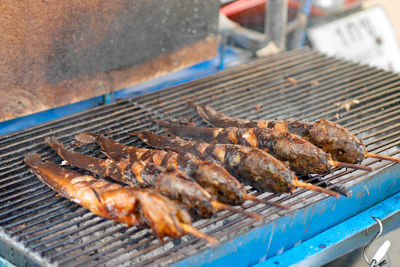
[134,131,296,193]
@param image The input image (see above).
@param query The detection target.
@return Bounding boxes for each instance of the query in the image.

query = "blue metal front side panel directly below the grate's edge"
[173,164,400,266]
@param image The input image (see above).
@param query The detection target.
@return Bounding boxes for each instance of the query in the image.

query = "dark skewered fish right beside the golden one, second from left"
[46,137,262,220]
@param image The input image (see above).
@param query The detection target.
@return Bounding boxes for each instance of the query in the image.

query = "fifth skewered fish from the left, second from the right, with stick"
[153,119,372,174]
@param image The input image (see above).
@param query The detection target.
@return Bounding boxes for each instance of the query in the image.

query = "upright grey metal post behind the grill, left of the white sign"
[264,0,288,50]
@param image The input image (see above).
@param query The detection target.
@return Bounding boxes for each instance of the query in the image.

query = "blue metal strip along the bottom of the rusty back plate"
[0,48,244,135]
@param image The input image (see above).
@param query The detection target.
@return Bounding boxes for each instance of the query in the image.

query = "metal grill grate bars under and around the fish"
[0,49,400,266]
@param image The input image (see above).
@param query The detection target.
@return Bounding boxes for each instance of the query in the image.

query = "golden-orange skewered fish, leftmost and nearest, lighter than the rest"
[25,154,218,244]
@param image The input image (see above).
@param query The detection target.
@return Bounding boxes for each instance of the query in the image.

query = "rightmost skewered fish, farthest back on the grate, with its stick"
[193,104,400,164]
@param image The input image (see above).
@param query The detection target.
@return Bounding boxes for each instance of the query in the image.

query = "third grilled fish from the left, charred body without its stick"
[77,133,246,205]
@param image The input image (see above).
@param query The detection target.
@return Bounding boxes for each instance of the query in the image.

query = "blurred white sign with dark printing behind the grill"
[307,6,400,72]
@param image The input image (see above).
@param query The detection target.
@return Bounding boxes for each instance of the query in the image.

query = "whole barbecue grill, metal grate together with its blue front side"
[0,48,400,266]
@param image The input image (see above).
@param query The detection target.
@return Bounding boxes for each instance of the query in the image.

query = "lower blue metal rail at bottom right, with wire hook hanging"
[256,187,400,267]
